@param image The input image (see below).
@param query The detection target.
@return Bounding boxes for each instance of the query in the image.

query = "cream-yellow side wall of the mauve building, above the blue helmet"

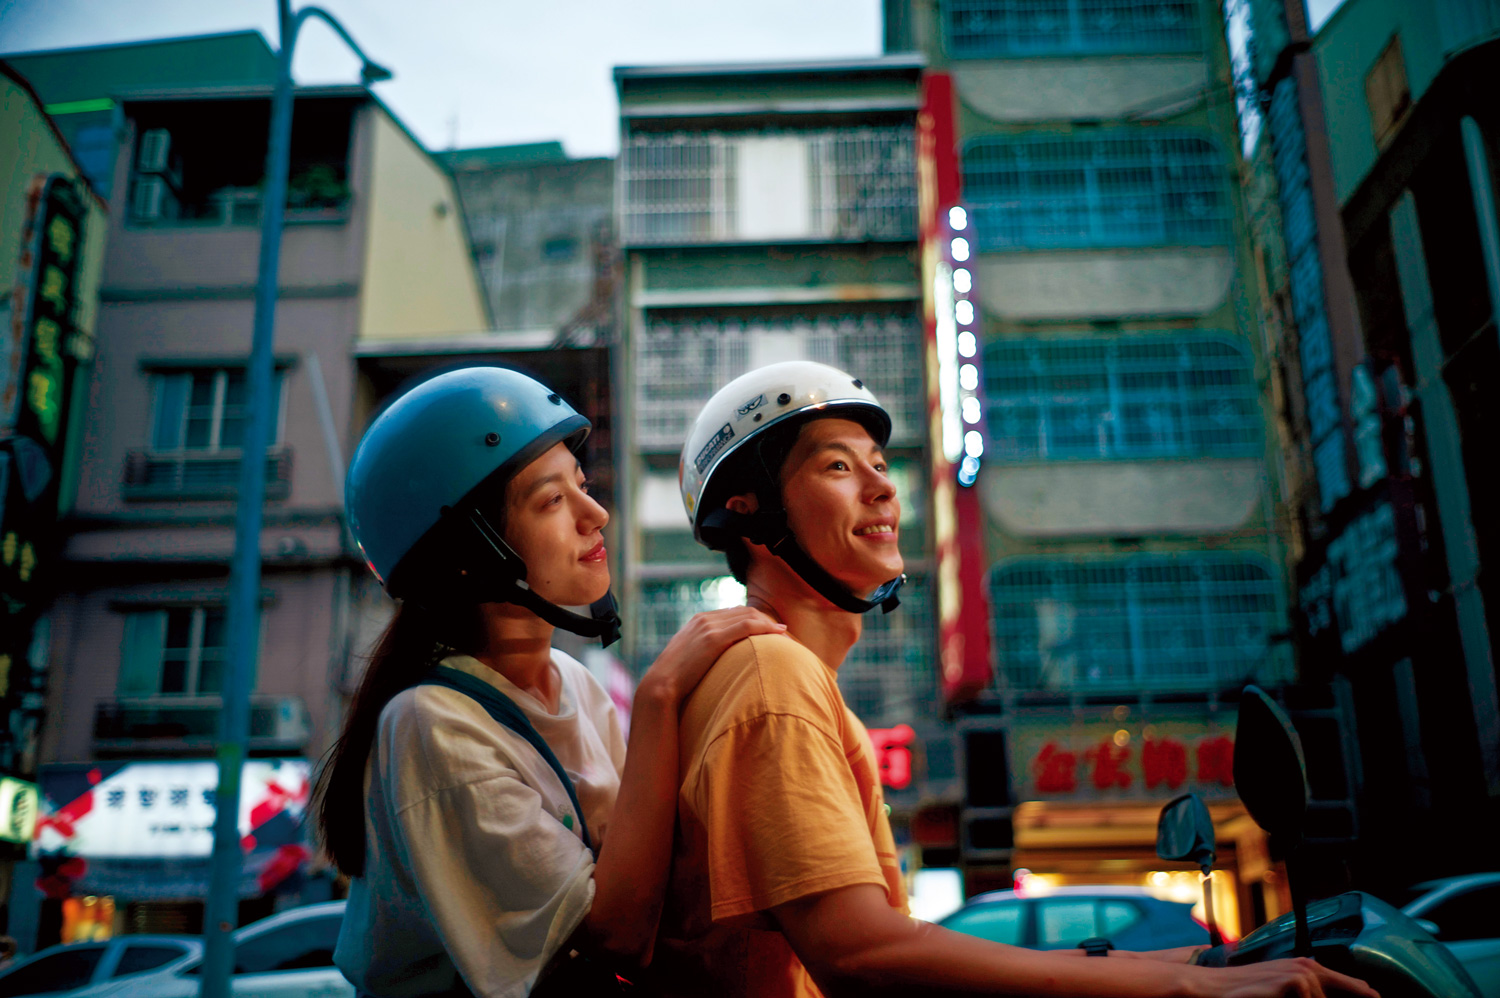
[359,114,489,339]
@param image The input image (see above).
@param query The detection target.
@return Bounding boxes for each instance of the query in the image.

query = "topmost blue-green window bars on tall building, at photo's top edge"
[942,0,1203,59]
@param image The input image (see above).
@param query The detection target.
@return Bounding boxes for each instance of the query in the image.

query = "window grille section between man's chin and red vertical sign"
[839,575,938,728]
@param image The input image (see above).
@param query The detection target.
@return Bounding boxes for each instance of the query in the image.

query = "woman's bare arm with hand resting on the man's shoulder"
[573,606,786,965]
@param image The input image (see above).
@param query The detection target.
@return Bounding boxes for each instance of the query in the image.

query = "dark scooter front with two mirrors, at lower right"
[1157,686,1479,998]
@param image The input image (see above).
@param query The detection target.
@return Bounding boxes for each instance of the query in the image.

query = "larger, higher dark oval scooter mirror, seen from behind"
[1235,686,1310,849]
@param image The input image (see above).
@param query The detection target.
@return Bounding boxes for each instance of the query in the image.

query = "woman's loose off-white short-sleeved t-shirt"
[335,650,626,998]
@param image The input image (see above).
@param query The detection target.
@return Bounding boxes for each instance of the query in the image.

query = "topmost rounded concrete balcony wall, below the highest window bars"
[950,56,1208,122]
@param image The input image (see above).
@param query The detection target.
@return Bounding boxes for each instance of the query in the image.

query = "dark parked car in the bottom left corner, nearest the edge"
[0,935,203,998]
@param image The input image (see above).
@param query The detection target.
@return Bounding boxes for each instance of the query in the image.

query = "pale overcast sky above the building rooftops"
[0,0,881,156]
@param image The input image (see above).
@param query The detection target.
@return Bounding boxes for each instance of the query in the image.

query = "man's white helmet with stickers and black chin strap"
[677,360,906,612]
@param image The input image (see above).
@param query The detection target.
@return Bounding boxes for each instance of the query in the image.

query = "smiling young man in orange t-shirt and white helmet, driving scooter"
[653,362,1374,998]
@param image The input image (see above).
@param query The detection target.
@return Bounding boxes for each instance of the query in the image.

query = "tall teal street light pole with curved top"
[200,0,392,998]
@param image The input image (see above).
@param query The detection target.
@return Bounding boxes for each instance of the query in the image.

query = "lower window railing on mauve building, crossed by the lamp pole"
[93,696,311,753]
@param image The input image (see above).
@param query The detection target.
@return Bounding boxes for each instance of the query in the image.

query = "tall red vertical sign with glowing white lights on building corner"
[917,72,993,702]
